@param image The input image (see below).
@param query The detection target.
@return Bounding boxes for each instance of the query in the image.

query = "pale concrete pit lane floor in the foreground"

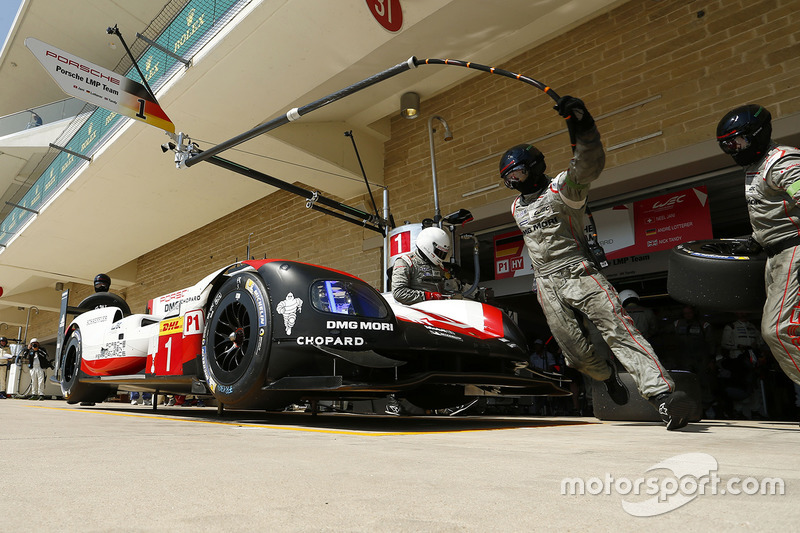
[0,399,800,533]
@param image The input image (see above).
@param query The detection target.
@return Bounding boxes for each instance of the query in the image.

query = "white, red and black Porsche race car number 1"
[52,259,569,409]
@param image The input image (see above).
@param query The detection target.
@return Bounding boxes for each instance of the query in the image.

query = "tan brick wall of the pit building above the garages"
[29,0,800,337]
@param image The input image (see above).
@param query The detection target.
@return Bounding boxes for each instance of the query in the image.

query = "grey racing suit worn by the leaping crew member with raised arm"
[512,128,674,398]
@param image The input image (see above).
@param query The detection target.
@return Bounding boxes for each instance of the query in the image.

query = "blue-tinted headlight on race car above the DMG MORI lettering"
[311,280,389,318]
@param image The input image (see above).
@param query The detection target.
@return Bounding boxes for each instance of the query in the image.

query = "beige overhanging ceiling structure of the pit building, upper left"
[0,0,623,325]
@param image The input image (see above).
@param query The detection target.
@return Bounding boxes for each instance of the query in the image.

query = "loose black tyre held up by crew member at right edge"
[667,239,767,312]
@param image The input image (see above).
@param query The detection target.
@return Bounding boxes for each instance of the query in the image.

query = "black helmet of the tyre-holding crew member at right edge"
[717,104,772,167]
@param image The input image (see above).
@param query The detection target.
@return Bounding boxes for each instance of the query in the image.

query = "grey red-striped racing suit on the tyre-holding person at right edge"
[745,143,800,384]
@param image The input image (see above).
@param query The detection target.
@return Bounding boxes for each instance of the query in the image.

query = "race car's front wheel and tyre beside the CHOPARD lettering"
[202,272,272,407]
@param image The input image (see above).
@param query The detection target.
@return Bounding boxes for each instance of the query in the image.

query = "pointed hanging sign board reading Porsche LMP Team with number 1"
[25,37,175,133]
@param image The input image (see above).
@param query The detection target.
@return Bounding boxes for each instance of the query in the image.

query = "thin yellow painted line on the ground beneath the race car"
[30,405,593,437]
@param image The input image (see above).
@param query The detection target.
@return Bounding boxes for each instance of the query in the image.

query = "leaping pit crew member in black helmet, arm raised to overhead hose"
[500,96,694,430]
